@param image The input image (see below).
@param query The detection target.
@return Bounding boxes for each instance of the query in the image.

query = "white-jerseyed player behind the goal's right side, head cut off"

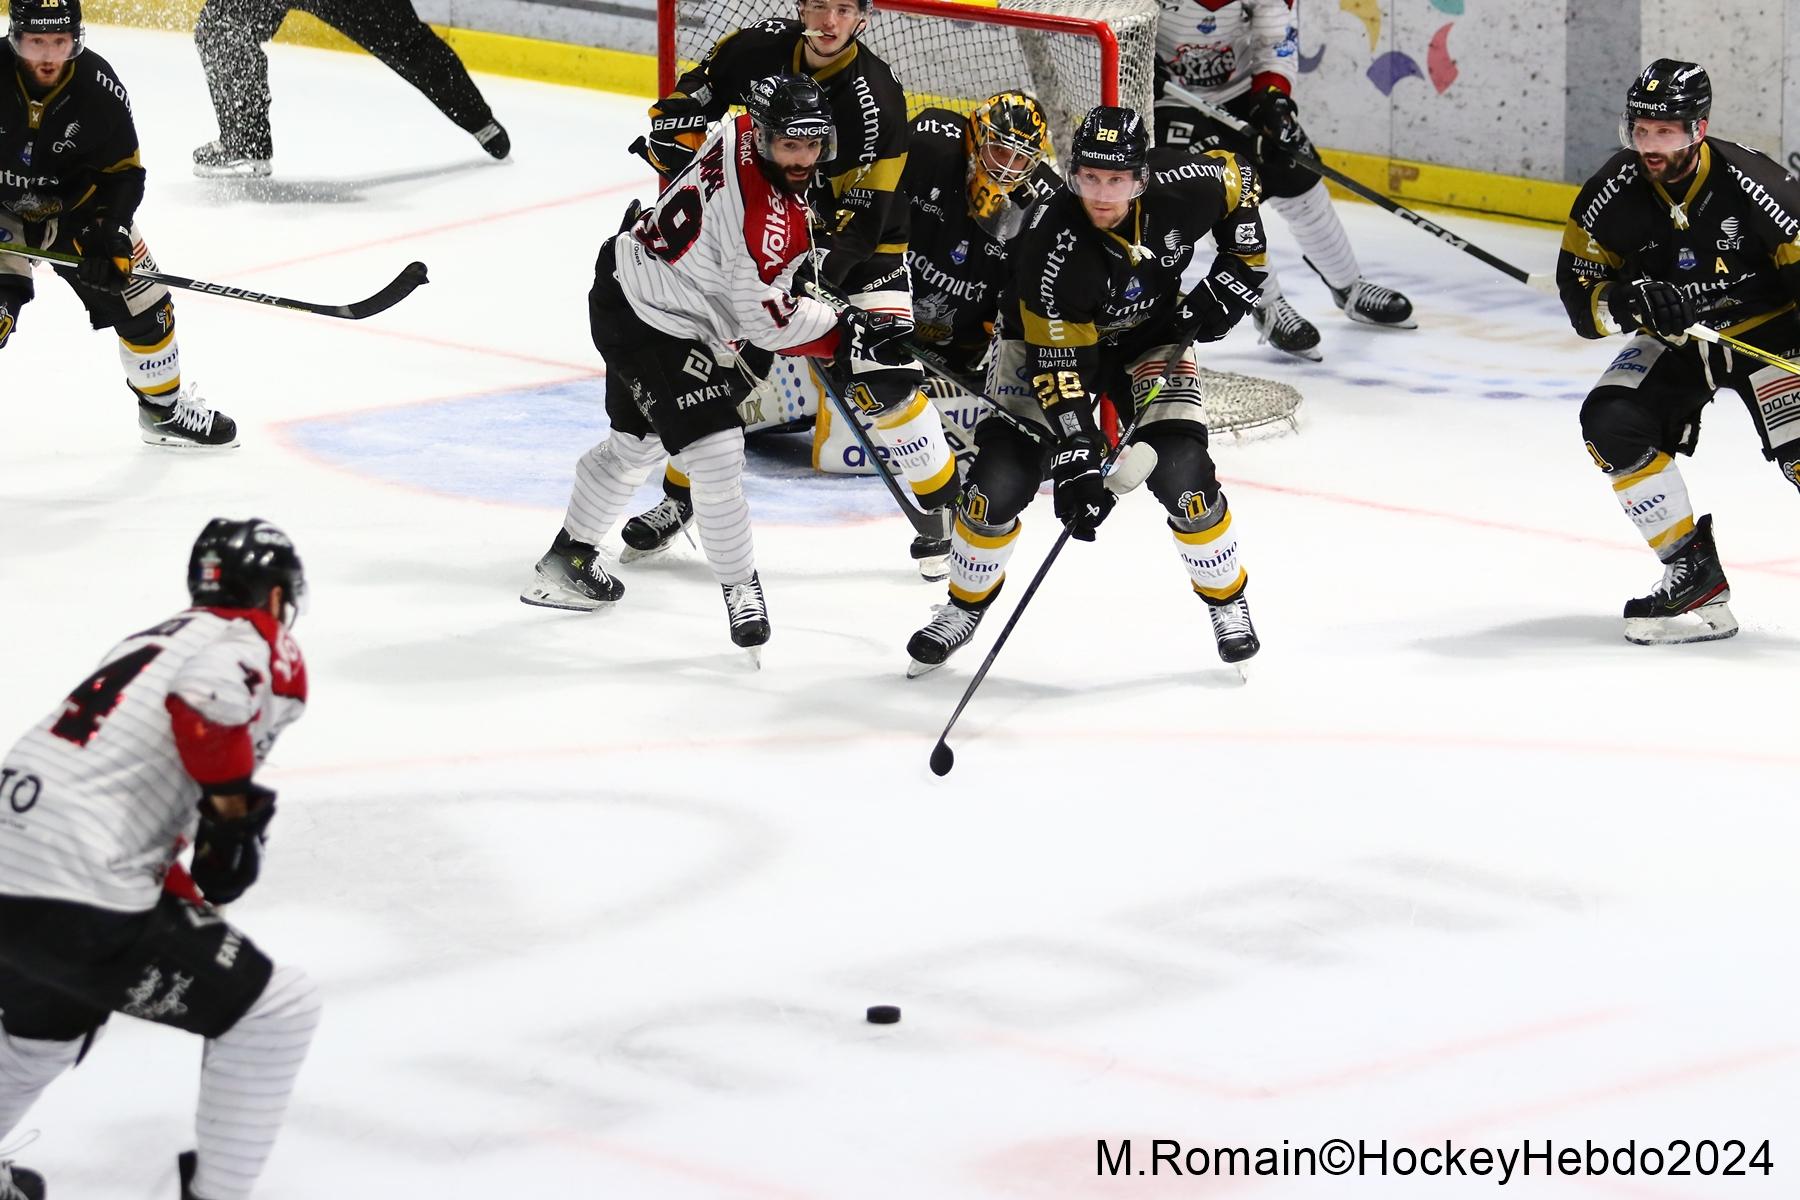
[1156,0,1417,362]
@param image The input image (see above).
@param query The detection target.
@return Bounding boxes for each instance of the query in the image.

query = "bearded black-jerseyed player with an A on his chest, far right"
[1557,59,1800,644]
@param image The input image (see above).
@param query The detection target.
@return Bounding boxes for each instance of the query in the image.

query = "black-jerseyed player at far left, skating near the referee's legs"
[0,0,238,450]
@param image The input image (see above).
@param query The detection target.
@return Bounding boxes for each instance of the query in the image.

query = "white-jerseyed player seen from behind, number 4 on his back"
[0,518,319,1200]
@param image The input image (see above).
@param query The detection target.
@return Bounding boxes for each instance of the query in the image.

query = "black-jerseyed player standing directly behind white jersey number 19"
[621,0,956,578]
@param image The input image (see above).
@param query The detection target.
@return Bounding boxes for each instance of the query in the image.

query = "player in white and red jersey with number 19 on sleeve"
[518,76,922,653]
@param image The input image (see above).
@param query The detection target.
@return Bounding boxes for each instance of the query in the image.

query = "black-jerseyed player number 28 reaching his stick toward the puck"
[907,106,1265,675]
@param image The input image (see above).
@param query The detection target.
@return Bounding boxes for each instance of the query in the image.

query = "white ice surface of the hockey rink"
[0,29,1800,1200]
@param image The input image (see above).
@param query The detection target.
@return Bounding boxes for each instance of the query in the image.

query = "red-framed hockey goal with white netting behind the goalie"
[657,0,1159,157]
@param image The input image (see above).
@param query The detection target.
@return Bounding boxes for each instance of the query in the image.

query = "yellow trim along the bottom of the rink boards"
[83,0,1580,225]
